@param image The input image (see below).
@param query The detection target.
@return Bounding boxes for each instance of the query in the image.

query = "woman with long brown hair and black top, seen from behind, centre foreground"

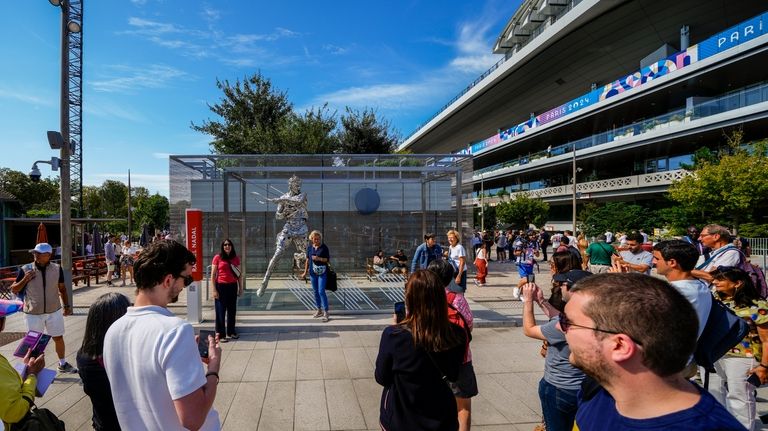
[374,269,467,431]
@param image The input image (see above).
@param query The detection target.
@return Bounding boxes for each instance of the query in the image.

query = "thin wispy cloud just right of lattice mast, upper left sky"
[90,64,189,93]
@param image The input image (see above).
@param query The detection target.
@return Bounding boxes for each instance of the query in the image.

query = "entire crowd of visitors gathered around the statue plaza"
[0,225,768,431]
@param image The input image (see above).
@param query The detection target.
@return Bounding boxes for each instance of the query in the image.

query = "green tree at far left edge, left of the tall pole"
[0,168,60,214]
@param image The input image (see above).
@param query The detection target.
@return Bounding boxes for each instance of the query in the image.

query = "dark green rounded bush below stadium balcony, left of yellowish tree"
[579,202,656,236]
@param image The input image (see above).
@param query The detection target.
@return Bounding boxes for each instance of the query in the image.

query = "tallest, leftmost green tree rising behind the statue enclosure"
[191,72,297,154]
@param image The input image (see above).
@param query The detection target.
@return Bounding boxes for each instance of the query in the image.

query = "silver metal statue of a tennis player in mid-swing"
[256,175,309,296]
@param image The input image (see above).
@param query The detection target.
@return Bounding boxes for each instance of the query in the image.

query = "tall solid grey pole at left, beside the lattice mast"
[59,2,74,306]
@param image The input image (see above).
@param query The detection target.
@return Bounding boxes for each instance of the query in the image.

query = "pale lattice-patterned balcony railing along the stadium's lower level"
[473,169,691,205]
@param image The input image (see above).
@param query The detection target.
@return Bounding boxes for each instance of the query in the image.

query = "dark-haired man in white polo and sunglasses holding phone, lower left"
[104,240,221,430]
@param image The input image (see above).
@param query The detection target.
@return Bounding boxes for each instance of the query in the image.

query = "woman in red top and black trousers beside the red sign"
[211,238,243,343]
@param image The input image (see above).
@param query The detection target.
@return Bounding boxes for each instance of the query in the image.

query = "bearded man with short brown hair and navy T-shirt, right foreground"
[559,273,745,431]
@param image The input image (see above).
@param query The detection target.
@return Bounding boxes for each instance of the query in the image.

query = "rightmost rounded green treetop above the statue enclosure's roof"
[337,107,399,154]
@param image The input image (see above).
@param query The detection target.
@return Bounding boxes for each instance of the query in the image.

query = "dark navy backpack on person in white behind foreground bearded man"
[693,298,749,389]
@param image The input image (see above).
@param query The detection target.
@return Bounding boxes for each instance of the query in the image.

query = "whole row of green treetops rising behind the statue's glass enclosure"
[191,72,399,154]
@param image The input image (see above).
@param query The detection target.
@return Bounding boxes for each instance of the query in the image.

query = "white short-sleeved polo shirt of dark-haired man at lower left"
[104,305,221,431]
